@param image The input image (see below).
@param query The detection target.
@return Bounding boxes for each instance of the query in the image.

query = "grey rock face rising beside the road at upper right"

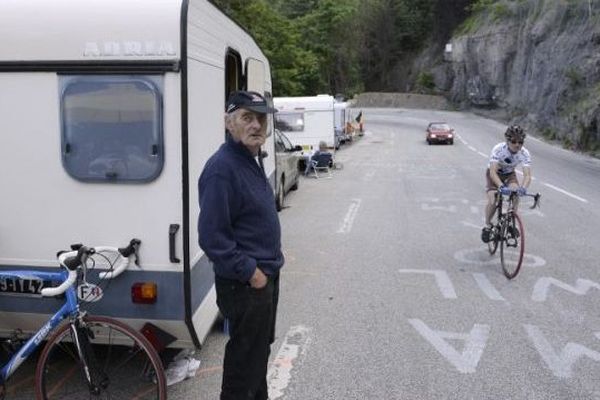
[442,0,600,152]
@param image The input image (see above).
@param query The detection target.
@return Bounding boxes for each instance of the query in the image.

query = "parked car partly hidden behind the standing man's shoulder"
[275,129,302,211]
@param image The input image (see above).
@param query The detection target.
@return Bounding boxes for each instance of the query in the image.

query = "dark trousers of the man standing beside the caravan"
[215,275,279,400]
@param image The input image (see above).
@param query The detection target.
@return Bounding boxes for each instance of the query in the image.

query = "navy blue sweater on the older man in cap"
[198,135,284,282]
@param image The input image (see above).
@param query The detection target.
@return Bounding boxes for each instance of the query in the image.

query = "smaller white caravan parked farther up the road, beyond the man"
[273,94,337,151]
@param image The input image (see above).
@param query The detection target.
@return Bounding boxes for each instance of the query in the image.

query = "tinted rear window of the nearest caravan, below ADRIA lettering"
[61,75,164,182]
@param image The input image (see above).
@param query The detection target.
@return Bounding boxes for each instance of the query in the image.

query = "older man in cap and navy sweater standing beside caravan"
[198,91,284,400]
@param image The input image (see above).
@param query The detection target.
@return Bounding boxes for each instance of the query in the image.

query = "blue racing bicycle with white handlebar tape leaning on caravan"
[0,239,167,400]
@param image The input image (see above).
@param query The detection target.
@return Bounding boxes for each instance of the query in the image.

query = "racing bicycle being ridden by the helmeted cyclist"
[488,187,541,279]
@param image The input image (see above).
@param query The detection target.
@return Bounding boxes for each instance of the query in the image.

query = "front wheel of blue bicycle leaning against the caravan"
[35,316,167,400]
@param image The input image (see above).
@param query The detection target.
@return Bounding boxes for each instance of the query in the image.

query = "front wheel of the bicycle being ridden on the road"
[499,213,525,279]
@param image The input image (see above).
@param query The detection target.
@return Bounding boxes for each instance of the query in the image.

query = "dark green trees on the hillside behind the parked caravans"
[211,0,476,97]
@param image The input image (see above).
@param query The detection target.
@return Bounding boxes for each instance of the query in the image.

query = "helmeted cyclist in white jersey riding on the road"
[481,125,531,243]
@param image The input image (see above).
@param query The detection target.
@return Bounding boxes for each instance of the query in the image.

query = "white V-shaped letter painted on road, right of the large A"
[523,324,600,378]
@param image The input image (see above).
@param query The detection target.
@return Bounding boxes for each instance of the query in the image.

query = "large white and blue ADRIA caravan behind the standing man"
[0,0,275,347]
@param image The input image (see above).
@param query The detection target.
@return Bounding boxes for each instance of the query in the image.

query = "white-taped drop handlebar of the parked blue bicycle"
[41,239,141,297]
